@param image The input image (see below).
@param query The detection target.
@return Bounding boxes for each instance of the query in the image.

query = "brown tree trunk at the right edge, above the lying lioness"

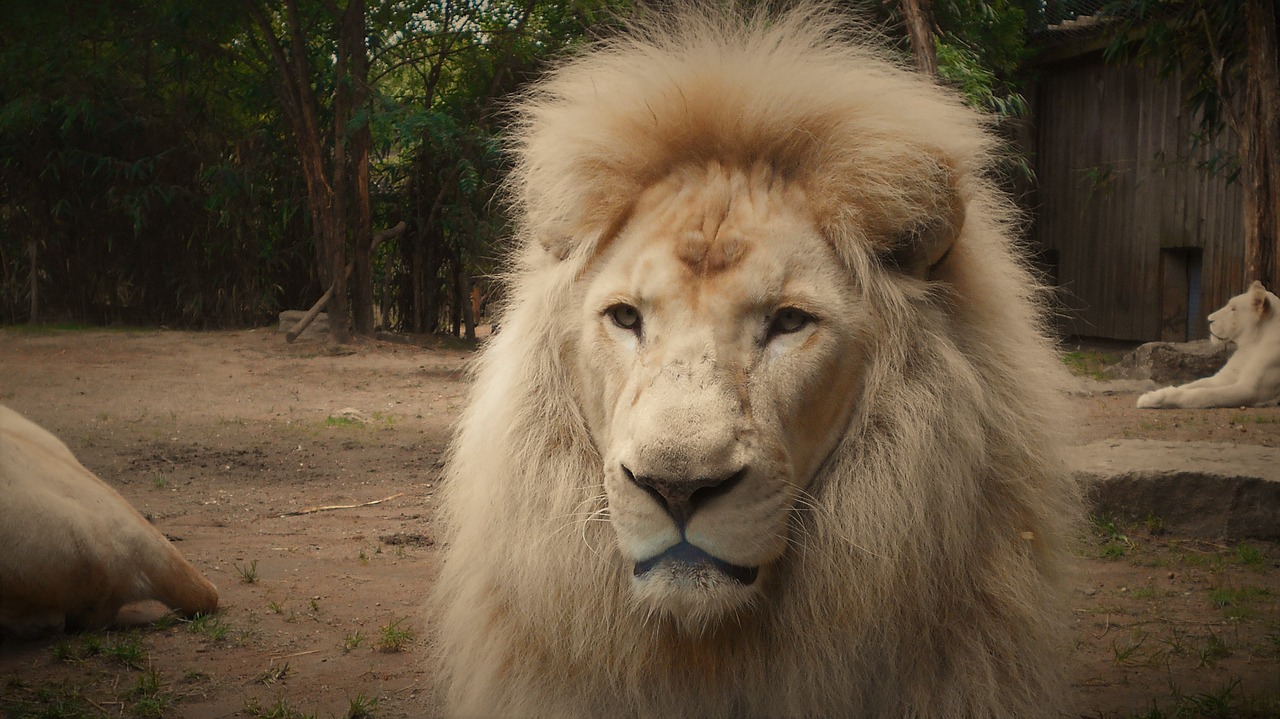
[1240,0,1280,290]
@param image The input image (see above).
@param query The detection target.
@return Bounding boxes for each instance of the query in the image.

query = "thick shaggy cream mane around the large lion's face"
[431,5,1078,719]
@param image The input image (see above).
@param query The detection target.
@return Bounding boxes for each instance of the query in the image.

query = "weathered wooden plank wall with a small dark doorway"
[1033,54,1244,342]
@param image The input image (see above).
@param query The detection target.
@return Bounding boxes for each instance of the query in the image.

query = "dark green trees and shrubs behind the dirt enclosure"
[0,0,1121,334]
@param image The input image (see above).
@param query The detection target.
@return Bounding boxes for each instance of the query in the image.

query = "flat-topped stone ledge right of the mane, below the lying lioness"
[1071,439,1280,541]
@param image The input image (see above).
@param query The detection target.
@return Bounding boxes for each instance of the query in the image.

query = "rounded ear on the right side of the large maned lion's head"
[881,164,965,279]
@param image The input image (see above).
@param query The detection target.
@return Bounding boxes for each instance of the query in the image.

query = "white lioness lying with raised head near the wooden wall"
[1138,281,1280,409]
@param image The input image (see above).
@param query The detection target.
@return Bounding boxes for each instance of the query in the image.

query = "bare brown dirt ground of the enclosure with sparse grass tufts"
[0,329,1280,719]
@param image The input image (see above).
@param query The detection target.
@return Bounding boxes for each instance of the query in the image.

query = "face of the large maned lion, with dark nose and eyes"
[579,165,870,627]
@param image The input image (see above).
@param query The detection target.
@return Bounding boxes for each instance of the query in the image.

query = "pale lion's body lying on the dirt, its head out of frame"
[0,407,218,636]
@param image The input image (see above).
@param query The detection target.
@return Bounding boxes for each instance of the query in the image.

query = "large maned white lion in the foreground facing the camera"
[433,5,1079,719]
